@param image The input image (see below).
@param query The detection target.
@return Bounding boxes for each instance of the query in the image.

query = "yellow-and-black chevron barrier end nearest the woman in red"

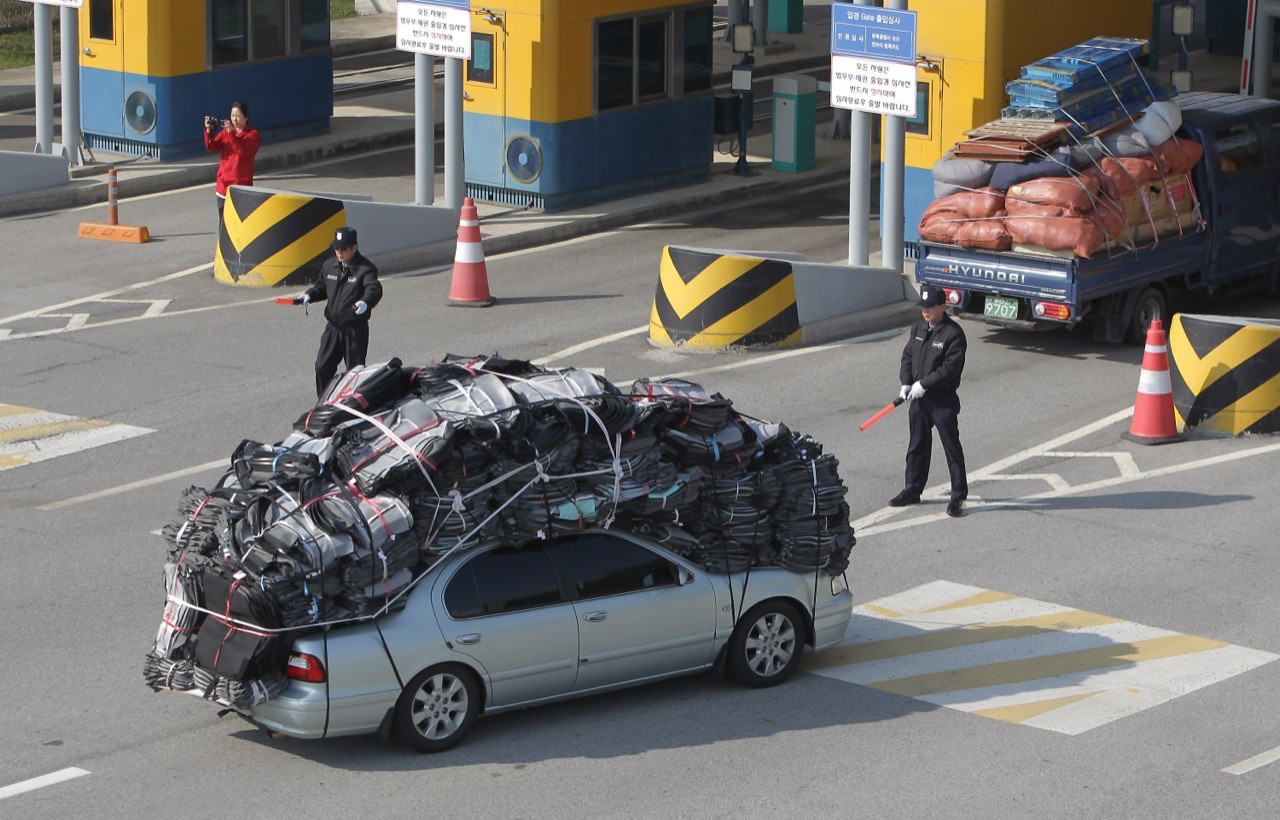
[214,188,346,288]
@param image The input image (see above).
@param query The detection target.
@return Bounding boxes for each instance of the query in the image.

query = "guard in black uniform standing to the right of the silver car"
[890,285,969,518]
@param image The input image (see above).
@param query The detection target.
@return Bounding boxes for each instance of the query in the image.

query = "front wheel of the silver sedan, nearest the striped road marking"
[724,601,804,688]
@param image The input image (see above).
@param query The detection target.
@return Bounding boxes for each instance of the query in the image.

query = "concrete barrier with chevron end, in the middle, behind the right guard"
[649,246,910,352]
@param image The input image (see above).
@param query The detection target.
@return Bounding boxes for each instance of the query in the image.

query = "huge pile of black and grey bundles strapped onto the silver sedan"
[143,356,855,709]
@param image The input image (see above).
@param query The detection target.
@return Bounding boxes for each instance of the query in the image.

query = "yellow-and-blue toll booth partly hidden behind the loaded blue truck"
[901,0,1152,257]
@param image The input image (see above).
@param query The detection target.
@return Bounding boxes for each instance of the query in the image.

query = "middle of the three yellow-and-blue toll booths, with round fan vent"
[462,0,714,211]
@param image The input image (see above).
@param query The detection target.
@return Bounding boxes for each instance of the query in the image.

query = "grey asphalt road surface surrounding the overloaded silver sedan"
[0,145,1280,817]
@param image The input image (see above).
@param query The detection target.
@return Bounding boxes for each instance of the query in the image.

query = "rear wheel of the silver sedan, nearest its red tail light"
[394,664,480,753]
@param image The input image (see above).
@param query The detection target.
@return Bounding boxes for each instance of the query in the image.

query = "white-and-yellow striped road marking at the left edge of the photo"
[0,404,155,469]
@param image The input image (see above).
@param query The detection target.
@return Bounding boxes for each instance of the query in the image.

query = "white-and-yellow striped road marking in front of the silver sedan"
[804,581,1277,734]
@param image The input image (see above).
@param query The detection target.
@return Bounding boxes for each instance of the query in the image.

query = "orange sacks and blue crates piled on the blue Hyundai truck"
[919,37,1203,258]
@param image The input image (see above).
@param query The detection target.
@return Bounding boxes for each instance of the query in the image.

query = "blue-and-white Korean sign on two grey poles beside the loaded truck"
[831,0,916,271]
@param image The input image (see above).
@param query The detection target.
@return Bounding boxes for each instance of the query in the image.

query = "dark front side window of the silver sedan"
[549,533,676,599]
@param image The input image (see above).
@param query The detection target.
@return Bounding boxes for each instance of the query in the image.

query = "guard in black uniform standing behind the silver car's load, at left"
[294,226,383,397]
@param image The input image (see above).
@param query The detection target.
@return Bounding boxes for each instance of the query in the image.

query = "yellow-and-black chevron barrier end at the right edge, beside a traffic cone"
[1169,313,1280,435]
